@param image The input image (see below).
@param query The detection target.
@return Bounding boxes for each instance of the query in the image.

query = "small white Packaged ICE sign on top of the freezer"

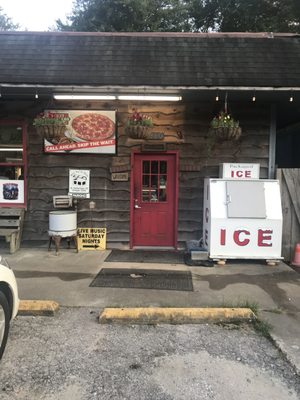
[219,163,260,179]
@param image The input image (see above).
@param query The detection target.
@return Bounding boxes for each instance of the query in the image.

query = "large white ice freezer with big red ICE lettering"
[203,166,282,264]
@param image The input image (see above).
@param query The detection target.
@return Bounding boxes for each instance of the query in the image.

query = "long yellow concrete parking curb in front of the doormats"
[99,307,256,324]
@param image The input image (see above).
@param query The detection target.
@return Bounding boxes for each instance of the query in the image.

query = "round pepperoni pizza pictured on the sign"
[71,113,115,142]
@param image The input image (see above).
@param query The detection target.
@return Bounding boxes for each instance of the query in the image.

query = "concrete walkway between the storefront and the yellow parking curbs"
[1,248,300,373]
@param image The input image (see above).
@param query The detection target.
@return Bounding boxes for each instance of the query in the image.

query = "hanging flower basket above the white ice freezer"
[210,111,242,140]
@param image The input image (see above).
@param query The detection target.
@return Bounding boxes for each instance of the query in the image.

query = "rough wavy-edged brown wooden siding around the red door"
[12,98,270,247]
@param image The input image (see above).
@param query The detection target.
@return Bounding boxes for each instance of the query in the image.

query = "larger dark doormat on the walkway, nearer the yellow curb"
[90,268,193,292]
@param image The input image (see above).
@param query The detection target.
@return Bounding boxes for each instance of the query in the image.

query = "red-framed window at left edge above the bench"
[0,121,26,206]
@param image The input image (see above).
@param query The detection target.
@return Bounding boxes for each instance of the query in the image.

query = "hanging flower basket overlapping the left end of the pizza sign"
[33,111,70,144]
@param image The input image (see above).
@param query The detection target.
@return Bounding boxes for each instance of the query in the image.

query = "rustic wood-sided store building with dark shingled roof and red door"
[0,32,300,249]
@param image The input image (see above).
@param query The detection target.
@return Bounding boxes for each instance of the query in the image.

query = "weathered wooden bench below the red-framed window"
[0,208,25,253]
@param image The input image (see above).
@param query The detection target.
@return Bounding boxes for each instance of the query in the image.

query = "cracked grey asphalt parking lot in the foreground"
[0,307,300,400]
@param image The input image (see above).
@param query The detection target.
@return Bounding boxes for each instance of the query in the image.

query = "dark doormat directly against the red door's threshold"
[105,249,184,264]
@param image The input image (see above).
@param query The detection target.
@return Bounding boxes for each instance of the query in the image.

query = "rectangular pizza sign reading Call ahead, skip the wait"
[44,110,116,154]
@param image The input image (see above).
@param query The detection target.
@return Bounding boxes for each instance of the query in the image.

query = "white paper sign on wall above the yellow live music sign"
[68,169,90,199]
